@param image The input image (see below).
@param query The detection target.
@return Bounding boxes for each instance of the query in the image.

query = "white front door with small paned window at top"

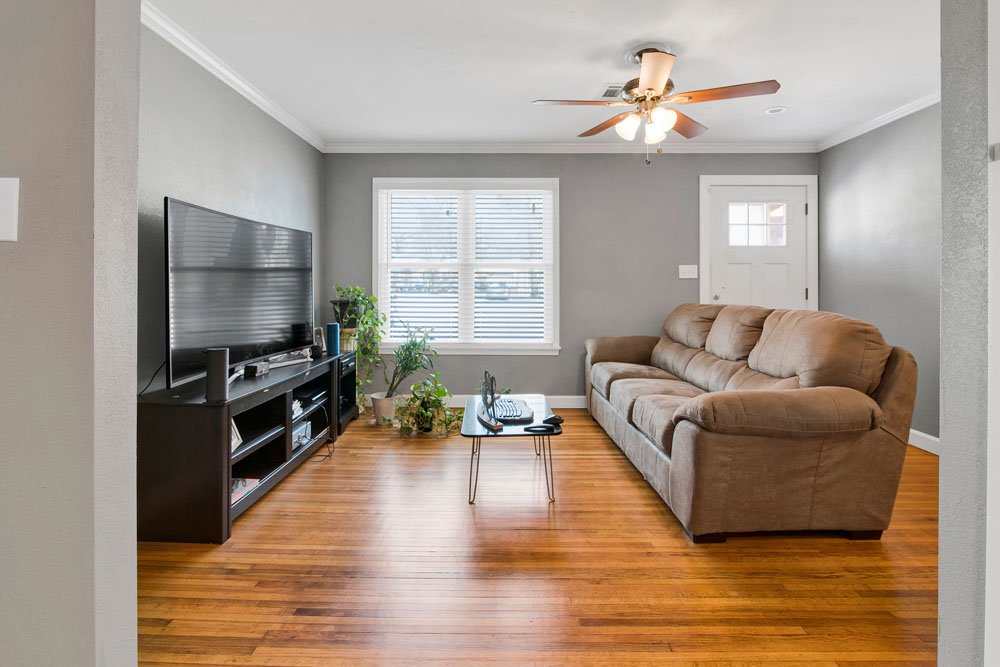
[701,177,817,309]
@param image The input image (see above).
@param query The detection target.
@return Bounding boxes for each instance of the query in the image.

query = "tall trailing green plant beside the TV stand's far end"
[330,285,385,412]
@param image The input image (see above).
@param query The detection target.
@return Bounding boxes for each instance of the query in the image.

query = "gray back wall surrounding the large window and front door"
[323,154,817,396]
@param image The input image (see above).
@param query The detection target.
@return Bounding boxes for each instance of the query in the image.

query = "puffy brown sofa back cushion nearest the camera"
[748,310,891,394]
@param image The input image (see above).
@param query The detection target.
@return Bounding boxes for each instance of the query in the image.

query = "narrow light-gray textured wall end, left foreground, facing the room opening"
[93,0,139,665]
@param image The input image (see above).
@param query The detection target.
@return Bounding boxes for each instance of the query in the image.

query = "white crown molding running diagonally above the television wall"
[140,0,323,150]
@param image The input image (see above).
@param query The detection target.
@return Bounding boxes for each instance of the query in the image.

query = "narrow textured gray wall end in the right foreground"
[938,0,997,666]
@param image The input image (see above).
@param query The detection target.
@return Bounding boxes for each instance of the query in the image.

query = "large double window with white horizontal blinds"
[373,178,559,354]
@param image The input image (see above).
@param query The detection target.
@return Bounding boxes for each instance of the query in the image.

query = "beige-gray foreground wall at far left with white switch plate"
[0,0,95,665]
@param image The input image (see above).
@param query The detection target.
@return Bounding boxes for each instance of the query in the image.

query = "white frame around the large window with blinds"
[372,178,561,356]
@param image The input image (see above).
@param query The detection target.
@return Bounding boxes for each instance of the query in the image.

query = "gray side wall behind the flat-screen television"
[138,28,324,389]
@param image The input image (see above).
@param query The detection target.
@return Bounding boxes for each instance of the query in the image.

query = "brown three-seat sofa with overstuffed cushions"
[585,304,917,542]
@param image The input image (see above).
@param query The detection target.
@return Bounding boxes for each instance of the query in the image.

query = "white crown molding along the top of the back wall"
[321,141,816,155]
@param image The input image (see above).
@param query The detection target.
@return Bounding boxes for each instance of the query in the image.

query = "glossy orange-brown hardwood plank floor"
[139,410,937,665]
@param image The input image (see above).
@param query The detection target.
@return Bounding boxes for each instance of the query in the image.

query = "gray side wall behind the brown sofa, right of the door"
[819,105,941,435]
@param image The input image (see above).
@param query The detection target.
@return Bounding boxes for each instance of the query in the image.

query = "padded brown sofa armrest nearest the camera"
[674,387,882,437]
